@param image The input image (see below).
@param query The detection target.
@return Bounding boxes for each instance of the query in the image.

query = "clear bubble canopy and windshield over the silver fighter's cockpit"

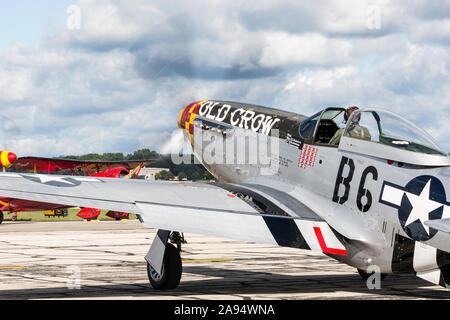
[299,108,450,166]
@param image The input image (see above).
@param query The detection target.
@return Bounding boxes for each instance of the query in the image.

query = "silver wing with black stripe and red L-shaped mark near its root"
[0,173,346,255]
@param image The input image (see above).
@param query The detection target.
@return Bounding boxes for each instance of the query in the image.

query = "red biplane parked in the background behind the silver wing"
[0,157,156,223]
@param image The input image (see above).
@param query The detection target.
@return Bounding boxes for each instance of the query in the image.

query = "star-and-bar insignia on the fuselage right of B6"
[380,175,450,241]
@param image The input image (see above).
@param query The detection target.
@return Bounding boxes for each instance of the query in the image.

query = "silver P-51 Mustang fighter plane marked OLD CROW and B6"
[0,101,450,289]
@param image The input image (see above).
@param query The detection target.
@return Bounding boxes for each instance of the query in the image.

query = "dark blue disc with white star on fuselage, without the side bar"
[398,175,447,241]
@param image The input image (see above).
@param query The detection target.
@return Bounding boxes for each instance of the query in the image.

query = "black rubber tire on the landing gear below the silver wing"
[147,243,182,290]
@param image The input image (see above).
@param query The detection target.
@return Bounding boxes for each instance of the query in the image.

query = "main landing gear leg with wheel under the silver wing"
[145,230,186,290]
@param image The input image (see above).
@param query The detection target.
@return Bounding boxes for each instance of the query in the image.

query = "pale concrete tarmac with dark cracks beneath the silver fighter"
[0,220,450,300]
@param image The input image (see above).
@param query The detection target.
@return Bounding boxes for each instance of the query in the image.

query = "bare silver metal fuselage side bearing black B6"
[186,100,450,273]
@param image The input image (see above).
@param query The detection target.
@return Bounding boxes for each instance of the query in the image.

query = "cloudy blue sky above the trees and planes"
[0,0,450,156]
